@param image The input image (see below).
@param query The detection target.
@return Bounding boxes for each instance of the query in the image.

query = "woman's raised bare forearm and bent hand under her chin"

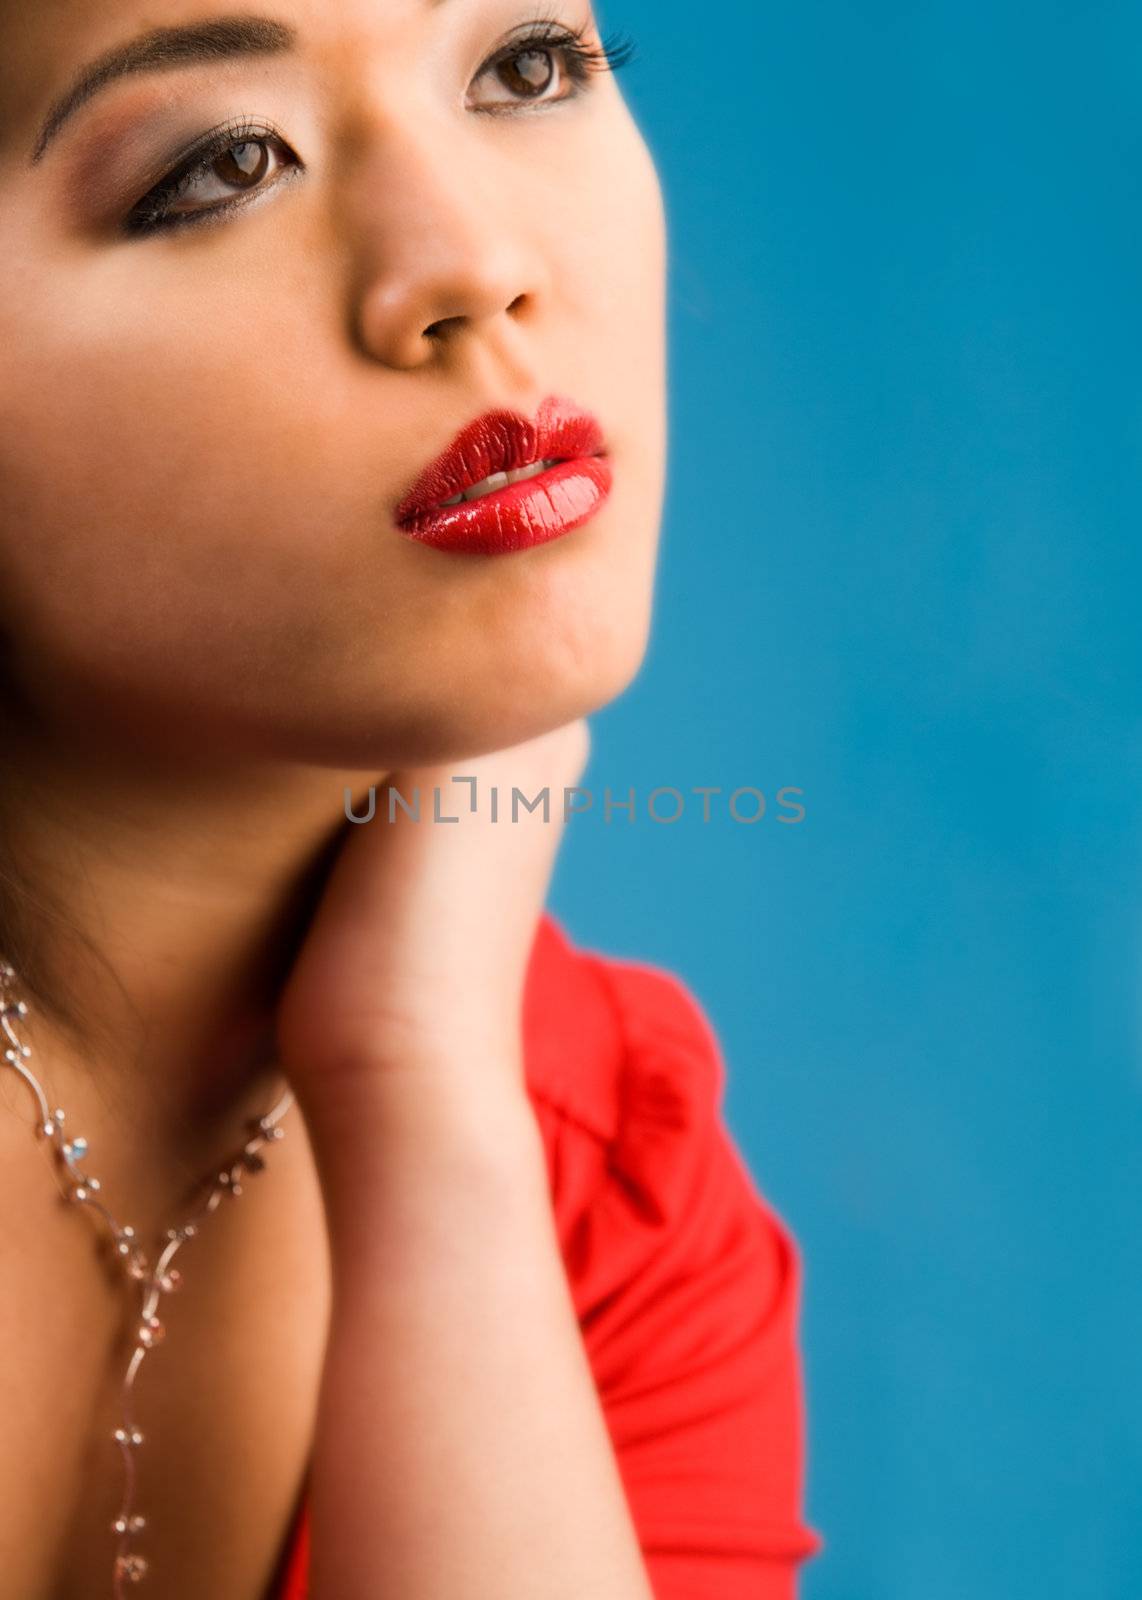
[282,723,651,1600]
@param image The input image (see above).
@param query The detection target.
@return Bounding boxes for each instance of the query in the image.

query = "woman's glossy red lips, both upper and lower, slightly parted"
[393,395,613,555]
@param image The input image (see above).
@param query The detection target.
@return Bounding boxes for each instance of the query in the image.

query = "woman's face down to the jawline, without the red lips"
[0,0,665,768]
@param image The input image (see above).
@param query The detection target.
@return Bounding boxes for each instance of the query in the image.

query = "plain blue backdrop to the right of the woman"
[552,0,1142,1600]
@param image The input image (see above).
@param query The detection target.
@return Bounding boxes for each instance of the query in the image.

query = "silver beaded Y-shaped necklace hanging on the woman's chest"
[0,962,293,1600]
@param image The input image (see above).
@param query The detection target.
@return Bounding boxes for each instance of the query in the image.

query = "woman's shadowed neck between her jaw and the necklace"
[0,716,384,1174]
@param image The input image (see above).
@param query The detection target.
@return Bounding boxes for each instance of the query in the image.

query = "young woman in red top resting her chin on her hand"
[0,0,819,1600]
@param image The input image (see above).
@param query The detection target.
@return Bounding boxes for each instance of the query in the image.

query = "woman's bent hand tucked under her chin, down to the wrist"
[277,722,590,1118]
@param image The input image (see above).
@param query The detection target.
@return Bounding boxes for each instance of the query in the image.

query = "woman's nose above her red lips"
[349,130,550,370]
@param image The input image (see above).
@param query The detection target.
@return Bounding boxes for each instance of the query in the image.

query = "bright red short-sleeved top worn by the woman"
[267,914,824,1600]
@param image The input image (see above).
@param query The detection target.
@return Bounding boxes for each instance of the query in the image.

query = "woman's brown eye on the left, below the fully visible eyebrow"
[123,125,299,235]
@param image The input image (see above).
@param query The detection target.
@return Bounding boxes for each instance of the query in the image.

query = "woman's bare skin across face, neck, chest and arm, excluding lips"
[0,0,665,1600]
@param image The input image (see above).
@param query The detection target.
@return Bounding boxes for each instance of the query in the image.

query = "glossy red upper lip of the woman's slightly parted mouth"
[395,395,606,523]
